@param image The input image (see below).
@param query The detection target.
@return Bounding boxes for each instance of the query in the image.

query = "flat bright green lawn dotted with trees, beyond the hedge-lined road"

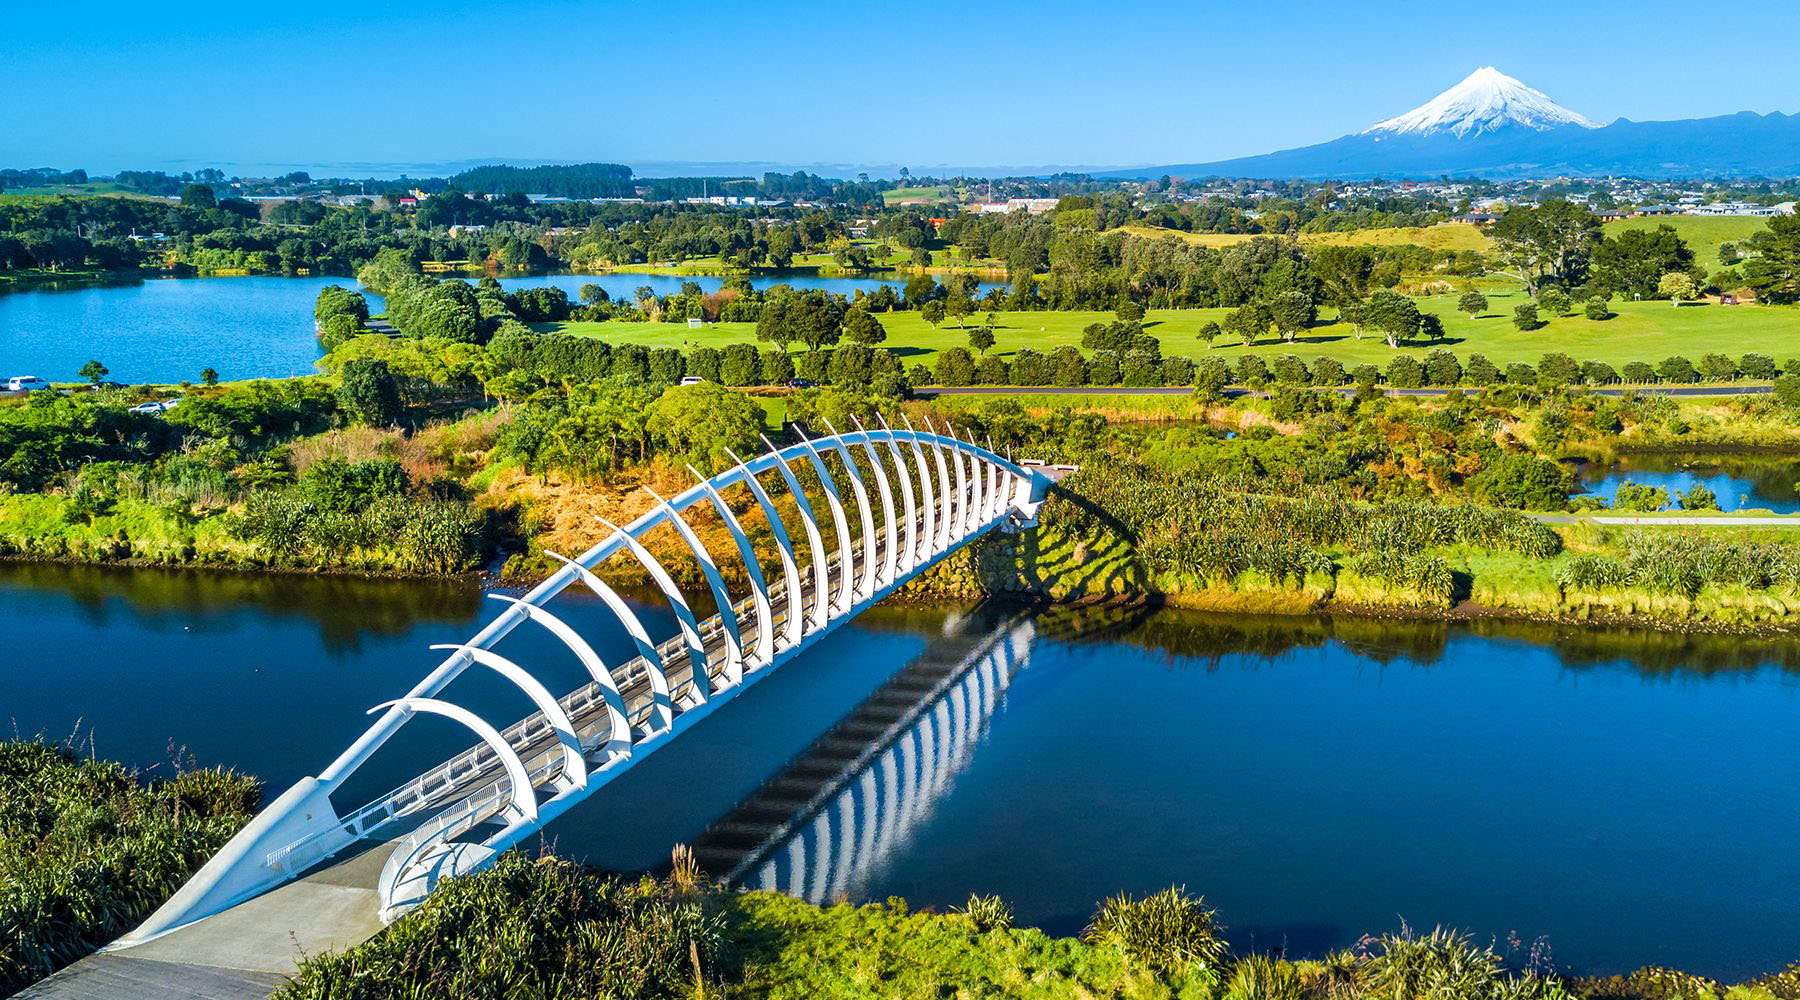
[538,290,1800,367]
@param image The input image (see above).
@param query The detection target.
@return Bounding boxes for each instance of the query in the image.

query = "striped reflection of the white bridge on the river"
[693,606,1037,903]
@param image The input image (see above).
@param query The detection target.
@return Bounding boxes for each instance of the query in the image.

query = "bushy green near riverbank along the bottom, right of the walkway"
[262,851,1800,1000]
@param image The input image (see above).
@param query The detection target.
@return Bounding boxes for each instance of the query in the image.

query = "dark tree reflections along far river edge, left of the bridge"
[0,563,481,651]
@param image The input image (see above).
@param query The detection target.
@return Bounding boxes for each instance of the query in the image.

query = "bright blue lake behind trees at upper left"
[0,273,992,385]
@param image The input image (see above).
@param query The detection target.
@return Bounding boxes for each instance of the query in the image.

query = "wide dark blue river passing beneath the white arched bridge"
[0,565,1800,978]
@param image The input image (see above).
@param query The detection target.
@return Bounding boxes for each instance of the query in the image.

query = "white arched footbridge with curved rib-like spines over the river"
[113,413,1051,950]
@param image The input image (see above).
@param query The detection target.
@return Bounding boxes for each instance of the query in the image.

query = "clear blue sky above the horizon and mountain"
[0,0,1800,173]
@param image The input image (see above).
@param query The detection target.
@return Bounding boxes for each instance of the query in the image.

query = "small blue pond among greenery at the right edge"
[1577,451,1800,514]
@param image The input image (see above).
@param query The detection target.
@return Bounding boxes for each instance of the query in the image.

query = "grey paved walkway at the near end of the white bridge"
[18,844,389,1000]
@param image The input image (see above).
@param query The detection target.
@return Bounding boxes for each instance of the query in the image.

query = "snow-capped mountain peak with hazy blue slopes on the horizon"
[1098,67,1800,180]
